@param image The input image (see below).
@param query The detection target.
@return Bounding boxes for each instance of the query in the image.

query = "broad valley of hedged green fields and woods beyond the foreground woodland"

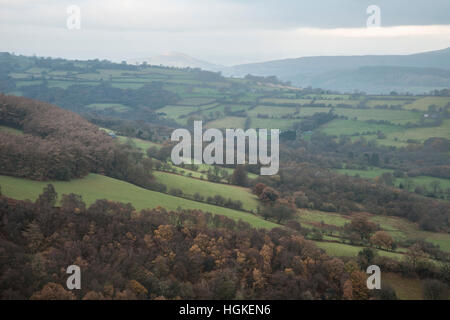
[0,54,450,298]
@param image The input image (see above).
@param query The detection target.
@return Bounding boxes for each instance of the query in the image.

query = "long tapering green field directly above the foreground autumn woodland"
[0,174,278,228]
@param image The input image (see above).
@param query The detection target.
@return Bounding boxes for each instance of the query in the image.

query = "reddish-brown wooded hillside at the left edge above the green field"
[0,94,152,187]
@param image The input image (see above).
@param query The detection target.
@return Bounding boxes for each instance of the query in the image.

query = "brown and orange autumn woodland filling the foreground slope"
[0,188,376,299]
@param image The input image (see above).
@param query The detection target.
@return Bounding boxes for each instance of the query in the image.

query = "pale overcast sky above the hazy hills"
[0,0,450,65]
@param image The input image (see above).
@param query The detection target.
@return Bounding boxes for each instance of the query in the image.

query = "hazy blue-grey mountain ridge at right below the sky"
[222,48,450,93]
